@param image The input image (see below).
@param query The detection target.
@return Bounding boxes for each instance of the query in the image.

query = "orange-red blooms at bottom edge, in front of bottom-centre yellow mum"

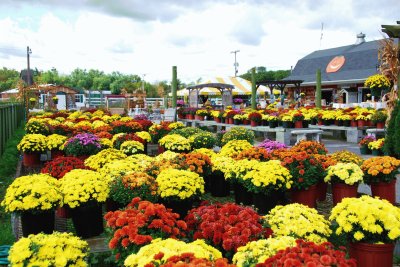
[144,252,236,267]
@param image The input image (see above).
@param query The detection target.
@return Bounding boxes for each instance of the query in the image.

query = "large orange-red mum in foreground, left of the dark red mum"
[104,197,187,266]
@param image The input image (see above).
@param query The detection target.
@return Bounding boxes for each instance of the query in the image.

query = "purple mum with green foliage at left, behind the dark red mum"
[64,133,101,159]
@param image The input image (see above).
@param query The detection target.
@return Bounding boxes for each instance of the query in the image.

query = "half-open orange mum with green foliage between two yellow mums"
[109,174,158,210]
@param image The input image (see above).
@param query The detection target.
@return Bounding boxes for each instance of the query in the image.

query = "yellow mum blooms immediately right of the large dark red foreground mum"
[264,203,331,243]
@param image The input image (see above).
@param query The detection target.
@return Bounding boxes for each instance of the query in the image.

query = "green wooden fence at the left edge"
[0,103,25,156]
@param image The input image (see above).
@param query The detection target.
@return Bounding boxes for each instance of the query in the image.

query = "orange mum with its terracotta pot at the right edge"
[361,156,400,204]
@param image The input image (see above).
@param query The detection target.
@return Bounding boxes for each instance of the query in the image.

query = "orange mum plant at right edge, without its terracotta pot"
[361,156,400,183]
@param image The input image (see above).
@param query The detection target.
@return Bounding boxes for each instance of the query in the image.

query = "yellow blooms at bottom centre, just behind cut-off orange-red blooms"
[124,238,222,267]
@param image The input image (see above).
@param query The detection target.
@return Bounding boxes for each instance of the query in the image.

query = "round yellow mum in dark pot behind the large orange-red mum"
[156,169,204,218]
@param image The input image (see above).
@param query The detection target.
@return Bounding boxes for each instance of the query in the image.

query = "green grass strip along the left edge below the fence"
[0,127,25,245]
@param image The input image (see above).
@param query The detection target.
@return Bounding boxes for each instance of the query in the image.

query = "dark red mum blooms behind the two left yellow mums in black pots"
[41,157,90,179]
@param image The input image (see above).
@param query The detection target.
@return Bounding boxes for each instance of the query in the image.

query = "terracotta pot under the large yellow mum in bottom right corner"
[349,243,394,267]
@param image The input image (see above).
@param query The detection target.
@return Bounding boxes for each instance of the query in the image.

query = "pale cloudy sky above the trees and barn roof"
[0,0,400,83]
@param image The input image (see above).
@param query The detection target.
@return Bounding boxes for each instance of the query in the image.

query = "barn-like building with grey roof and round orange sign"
[284,33,380,105]
